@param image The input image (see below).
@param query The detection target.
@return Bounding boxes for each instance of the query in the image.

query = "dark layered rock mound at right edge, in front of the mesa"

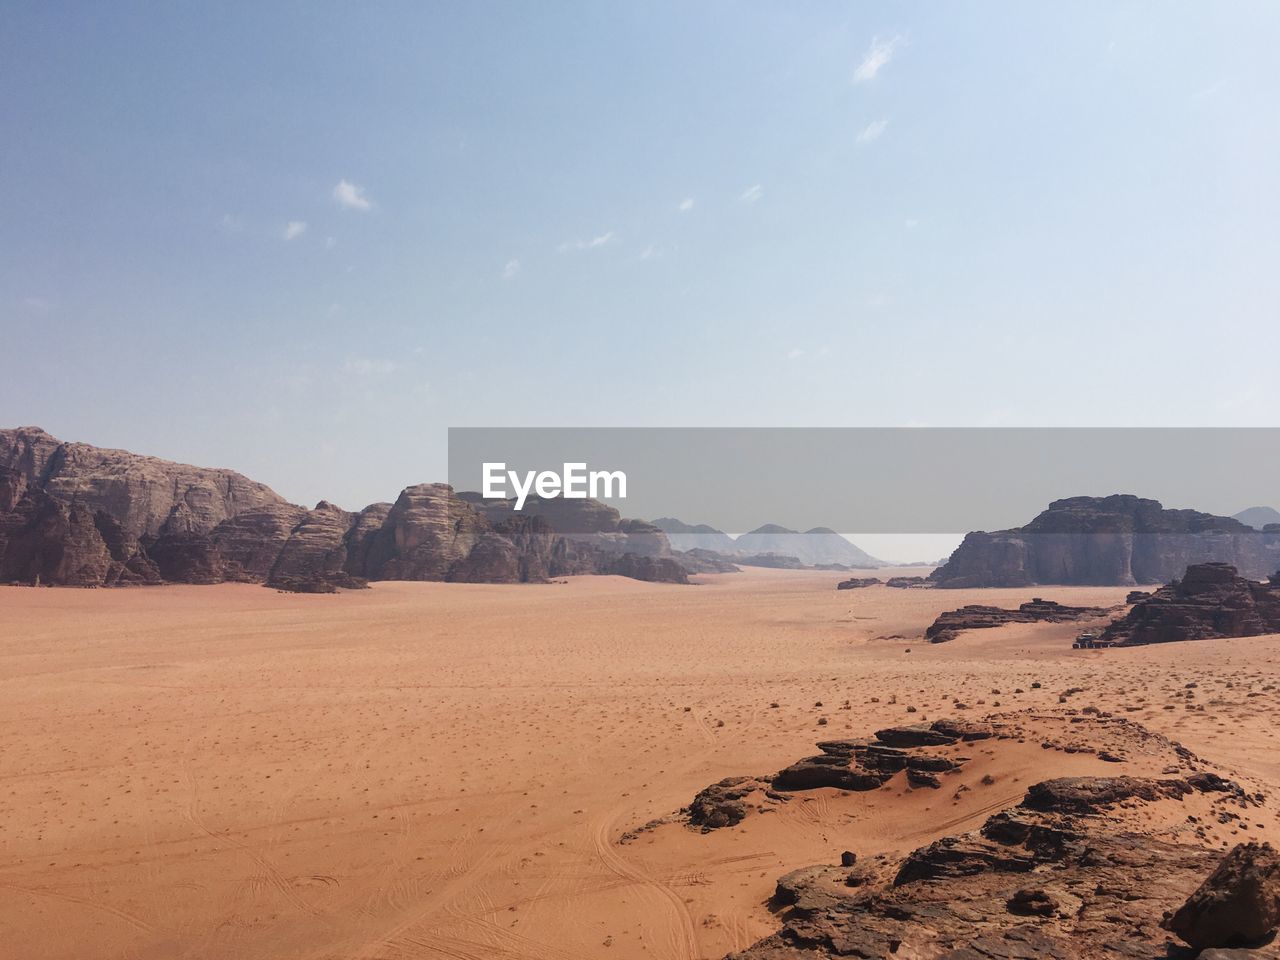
[1101,563,1280,646]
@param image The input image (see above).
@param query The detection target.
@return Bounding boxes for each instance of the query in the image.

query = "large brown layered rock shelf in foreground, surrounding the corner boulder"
[722,718,1264,960]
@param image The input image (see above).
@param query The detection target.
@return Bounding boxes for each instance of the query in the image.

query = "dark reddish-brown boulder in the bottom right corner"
[1166,844,1280,950]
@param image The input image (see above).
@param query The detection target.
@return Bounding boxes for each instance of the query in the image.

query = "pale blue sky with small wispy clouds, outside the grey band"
[0,0,1280,552]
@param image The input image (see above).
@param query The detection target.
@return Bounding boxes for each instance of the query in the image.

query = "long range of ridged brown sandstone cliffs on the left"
[0,428,691,593]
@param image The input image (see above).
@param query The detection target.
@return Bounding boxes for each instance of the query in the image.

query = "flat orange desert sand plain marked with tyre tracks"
[0,570,1280,960]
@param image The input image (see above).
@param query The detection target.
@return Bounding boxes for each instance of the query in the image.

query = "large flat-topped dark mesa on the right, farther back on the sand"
[929,495,1280,588]
